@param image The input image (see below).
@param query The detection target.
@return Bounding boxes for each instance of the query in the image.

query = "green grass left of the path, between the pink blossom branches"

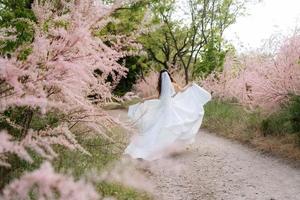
[54,129,150,200]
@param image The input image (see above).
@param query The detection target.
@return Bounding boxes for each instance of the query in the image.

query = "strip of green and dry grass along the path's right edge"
[202,100,300,161]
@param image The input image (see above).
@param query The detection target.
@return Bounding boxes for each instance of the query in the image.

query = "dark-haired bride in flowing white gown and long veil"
[124,70,211,161]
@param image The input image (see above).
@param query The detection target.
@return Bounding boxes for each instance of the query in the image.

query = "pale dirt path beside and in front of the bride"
[108,111,300,200]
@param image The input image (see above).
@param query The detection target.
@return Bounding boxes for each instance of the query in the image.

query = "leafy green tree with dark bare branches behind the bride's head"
[145,0,244,83]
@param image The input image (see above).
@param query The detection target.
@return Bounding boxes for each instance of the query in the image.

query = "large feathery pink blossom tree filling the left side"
[0,0,140,199]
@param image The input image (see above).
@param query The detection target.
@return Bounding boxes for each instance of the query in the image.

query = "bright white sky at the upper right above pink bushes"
[225,0,300,51]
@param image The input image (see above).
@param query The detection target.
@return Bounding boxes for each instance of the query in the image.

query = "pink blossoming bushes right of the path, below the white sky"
[202,35,300,111]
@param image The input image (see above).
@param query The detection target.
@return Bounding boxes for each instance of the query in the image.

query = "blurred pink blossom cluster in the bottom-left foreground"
[0,162,100,200]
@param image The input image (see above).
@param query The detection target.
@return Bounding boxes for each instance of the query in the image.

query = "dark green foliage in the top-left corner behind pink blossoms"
[0,0,35,55]
